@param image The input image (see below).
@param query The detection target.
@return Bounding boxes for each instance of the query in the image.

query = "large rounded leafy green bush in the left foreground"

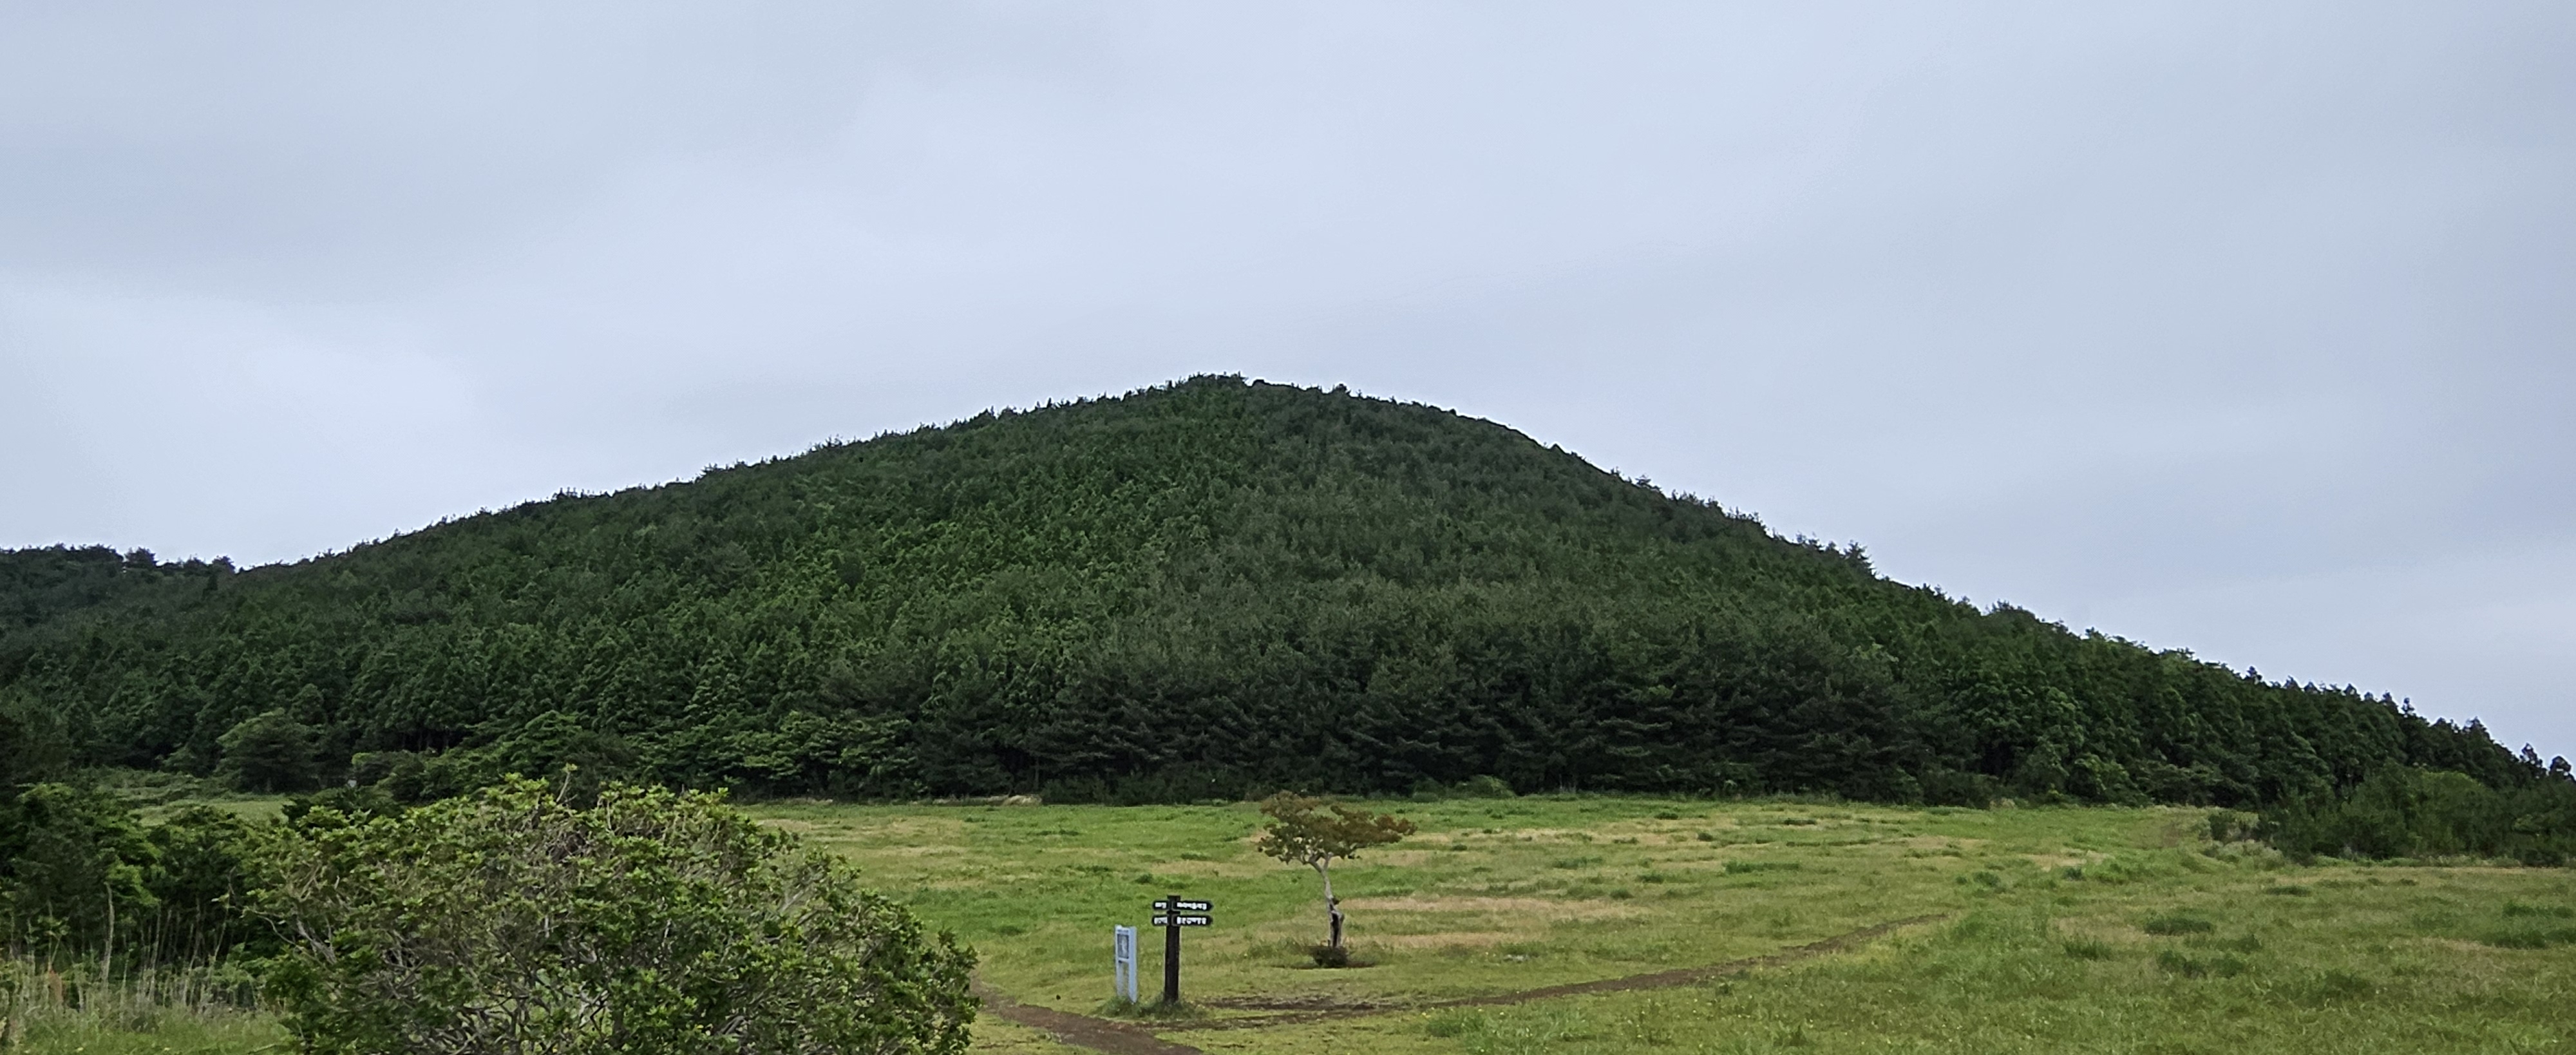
[260,780,974,1055]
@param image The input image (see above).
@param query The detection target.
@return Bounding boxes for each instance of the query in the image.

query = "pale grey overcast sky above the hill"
[0,0,2576,754]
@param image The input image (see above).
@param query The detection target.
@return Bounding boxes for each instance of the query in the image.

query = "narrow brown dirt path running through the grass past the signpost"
[976,913,1947,1055]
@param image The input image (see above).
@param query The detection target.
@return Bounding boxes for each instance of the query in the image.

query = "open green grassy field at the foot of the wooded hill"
[26,797,2576,1055]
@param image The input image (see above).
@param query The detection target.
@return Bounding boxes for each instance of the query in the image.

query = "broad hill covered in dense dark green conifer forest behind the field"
[0,378,2540,805]
